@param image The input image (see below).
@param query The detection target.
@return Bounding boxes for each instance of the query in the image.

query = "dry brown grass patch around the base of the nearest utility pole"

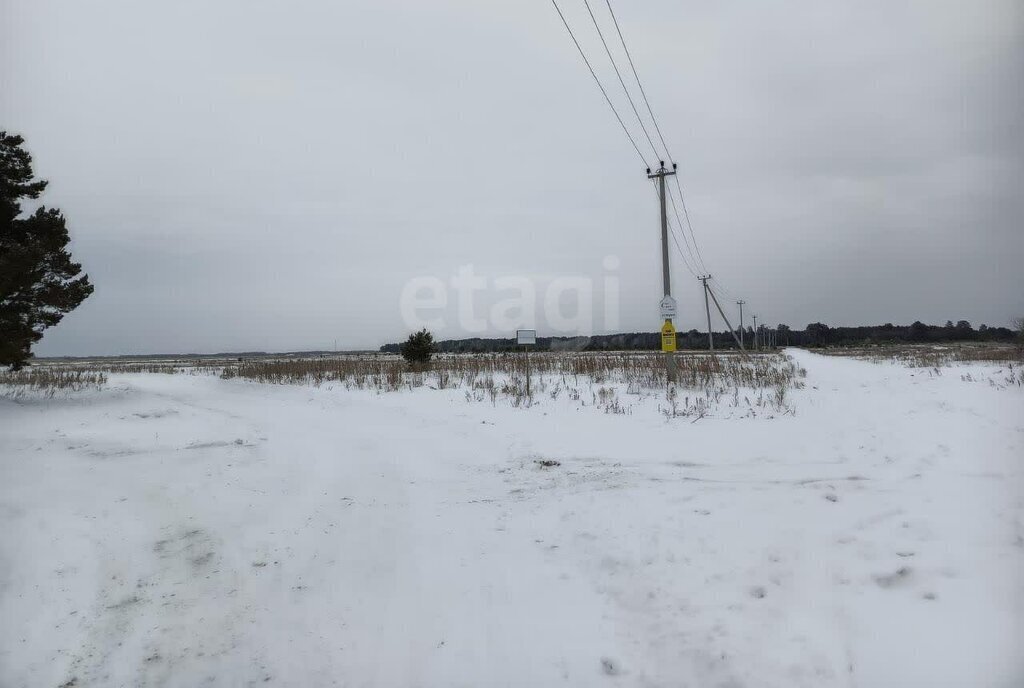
[221,352,806,417]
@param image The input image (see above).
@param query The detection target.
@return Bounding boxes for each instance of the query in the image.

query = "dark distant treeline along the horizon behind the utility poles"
[380,320,1019,353]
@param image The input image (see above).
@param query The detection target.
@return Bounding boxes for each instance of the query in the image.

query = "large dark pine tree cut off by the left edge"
[0,131,93,370]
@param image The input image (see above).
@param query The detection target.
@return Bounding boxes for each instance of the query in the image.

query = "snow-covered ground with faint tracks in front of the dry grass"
[0,351,1024,688]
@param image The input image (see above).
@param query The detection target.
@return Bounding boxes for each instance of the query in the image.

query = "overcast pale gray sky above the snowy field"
[0,0,1024,355]
